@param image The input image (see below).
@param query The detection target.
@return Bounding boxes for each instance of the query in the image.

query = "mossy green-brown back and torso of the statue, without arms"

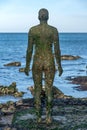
[31,24,55,66]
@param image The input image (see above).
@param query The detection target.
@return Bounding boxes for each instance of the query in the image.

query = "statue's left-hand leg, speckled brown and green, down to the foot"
[32,69,42,122]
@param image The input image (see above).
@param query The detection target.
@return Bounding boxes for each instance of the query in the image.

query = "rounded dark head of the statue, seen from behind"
[38,8,49,21]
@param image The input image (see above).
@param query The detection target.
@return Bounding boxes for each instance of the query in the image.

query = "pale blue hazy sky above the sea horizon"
[0,0,87,32]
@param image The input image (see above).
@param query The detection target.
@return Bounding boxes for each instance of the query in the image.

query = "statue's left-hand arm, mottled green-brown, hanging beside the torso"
[25,30,33,75]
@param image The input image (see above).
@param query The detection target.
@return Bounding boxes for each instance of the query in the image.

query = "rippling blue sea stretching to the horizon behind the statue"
[0,33,87,103]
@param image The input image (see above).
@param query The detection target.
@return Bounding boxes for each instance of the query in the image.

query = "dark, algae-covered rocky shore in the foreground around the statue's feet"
[0,96,87,130]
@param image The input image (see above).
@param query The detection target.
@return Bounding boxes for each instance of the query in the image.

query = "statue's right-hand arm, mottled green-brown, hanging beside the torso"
[54,30,63,76]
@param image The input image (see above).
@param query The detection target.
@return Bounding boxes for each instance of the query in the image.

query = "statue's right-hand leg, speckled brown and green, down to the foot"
[45,67,55,123]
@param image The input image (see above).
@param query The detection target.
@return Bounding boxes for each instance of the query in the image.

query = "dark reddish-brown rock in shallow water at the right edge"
[67,76,87,91]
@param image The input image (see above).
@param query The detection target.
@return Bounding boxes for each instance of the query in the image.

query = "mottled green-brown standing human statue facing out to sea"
[25,8,63,123]
